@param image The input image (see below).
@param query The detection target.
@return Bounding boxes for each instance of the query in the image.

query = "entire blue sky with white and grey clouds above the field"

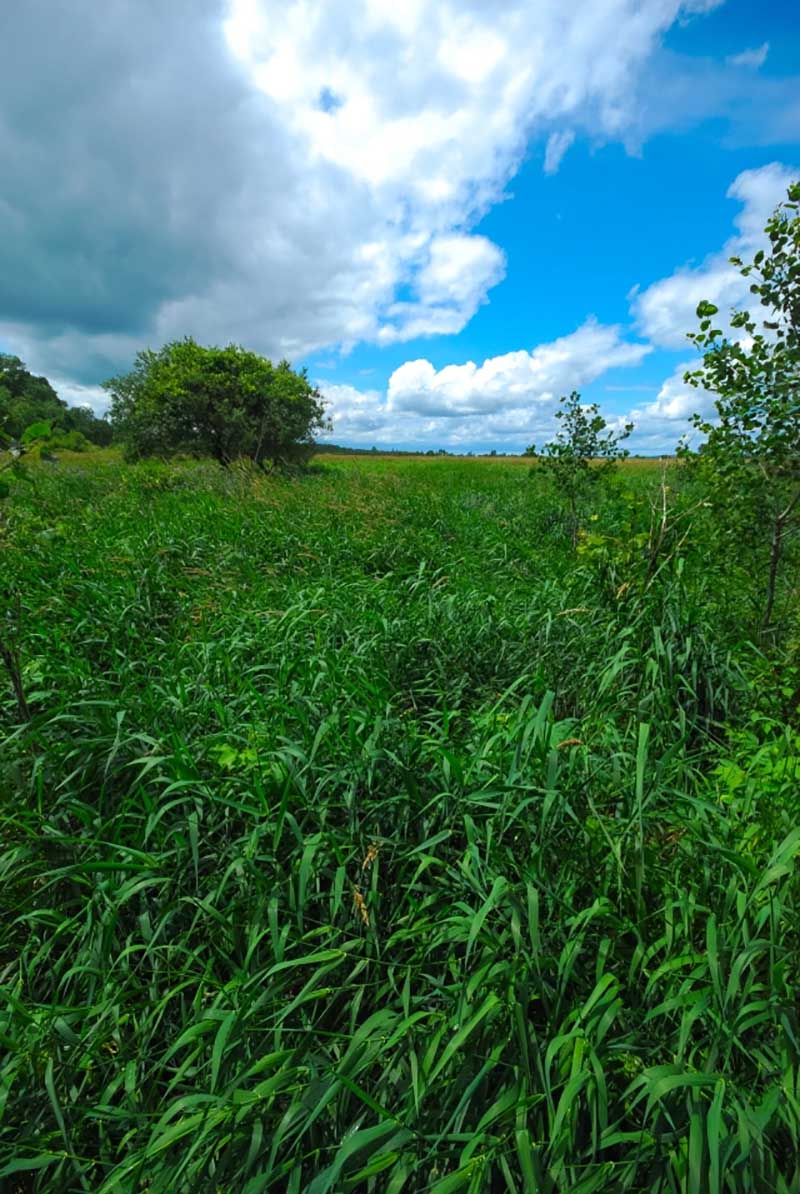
[0,0,800,454]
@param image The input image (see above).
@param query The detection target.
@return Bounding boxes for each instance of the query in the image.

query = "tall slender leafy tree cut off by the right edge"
[684,183,800,630]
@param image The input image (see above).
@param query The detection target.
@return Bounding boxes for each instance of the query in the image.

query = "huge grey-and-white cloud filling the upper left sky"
[0,0,745,384]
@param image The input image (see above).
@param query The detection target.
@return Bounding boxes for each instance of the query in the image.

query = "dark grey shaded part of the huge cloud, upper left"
[0,0,250,333]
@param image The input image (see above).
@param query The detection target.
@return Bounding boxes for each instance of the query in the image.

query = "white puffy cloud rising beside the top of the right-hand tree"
[632,162,800,349]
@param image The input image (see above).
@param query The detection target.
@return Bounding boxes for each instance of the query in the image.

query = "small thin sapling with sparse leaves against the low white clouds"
[525,390,633,544]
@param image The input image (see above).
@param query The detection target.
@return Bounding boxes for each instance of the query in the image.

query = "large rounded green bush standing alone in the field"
[105,338,327,467]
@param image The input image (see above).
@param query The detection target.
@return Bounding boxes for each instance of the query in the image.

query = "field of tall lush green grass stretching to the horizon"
[0,453,800,1194]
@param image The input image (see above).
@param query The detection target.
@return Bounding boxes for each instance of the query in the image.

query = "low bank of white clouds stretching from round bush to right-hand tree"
[322,162,800,453]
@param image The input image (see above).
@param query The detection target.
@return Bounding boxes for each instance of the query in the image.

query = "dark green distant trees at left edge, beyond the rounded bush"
[0,353,112,445]
